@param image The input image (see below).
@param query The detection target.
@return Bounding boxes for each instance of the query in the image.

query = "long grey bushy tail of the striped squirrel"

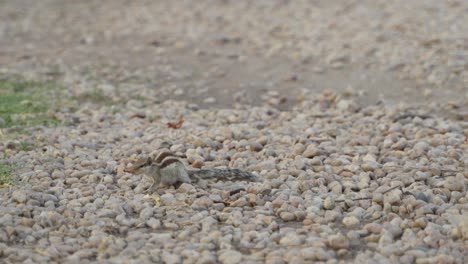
[189,169,262,182]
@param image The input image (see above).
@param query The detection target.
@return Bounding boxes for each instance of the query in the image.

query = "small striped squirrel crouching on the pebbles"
[124,151,262,190]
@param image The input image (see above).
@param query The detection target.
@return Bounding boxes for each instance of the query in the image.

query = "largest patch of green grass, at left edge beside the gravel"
[0,75,59,128]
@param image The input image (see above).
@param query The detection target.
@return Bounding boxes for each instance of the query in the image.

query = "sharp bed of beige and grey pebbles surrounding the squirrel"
[0,89,468,263]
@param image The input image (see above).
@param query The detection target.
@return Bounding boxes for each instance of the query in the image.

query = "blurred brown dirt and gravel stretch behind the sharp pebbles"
[0,0,468,111]
